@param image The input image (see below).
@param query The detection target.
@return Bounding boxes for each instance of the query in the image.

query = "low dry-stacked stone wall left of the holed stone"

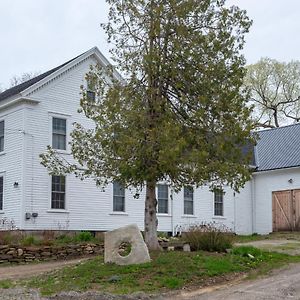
[0,243,104,264]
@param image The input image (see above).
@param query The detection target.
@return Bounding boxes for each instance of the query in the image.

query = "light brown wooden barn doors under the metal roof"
[272,190,300,231]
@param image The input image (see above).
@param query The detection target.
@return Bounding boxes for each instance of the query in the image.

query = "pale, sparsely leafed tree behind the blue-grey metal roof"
[245,58,300,128]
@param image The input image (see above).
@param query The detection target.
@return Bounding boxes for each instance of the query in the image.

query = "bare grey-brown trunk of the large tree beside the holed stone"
[144,182,161,250]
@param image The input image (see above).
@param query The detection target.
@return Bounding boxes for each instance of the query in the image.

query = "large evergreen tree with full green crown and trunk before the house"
[42,0,253,249]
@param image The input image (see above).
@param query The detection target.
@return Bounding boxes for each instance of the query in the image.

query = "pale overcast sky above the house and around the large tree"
[0,0,300,87]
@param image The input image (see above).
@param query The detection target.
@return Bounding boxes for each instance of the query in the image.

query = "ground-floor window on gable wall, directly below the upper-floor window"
[51,176,66,209]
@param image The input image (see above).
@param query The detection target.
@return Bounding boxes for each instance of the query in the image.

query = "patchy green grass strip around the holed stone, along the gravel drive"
[0,247,300,295]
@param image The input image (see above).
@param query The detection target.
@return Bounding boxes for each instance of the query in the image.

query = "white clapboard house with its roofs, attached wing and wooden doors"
[0,48,300,234]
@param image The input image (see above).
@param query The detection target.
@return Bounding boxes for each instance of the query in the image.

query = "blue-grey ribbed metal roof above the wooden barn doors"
[255,123,300,171]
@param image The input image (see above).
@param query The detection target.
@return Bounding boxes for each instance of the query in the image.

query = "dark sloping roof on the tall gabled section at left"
[0,51,88,101]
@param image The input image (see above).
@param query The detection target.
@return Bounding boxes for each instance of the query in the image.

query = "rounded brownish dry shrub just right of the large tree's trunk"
[183,222,233,252]
